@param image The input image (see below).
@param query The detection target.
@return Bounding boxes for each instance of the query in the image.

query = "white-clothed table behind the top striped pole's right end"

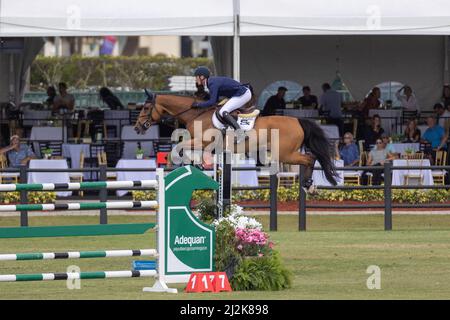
[116,159,156,197]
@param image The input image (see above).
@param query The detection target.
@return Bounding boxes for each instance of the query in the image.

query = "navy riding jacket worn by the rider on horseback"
[193,77,248,108]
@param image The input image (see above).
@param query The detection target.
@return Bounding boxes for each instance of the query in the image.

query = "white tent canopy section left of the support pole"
[0,0,233,37]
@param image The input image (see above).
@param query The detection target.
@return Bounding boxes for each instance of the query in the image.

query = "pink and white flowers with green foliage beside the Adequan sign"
[199,206,292,290]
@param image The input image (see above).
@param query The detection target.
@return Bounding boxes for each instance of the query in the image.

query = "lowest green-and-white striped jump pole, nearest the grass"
[0,270,157,282]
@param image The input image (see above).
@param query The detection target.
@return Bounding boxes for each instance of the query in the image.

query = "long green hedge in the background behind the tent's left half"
[30,55,212,91]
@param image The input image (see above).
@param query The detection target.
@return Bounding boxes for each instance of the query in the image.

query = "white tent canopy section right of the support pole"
[240,0,450,36]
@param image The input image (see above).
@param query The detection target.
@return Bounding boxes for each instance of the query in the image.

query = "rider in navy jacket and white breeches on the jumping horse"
[192,67,252,139]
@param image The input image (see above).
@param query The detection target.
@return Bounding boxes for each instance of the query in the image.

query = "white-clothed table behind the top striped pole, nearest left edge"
[28,159,72,197]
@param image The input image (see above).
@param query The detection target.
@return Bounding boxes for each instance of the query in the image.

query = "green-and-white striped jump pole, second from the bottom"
[0,249,157,261]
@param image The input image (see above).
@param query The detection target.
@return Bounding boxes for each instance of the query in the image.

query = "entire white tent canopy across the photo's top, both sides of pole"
[0,0,450,37]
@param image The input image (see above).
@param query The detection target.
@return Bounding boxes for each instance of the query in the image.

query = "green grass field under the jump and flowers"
[0,215,450,299]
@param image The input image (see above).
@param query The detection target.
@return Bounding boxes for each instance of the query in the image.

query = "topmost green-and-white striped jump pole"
[0,180,158,191]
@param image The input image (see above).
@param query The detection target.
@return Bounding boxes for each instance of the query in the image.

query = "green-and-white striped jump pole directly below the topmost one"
[0,201,158,212]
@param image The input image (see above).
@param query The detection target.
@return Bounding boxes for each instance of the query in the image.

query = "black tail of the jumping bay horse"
[298,119,338,185]
